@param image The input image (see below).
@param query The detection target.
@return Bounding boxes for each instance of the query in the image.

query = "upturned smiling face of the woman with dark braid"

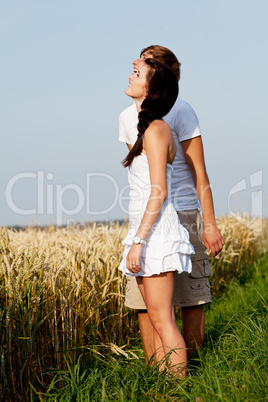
[125,62,149,100]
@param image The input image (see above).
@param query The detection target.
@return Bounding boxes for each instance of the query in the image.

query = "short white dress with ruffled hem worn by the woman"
[119,153,194,276]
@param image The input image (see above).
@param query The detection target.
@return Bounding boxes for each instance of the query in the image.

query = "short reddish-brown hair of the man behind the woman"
[140,45,181,81]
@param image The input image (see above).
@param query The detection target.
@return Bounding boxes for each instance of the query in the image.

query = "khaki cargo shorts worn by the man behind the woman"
[125,209,211,310]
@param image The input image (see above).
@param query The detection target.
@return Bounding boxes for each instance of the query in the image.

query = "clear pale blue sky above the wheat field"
[0,0,268,225]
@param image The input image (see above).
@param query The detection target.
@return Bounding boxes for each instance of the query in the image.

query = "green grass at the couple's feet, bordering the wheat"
[38,255,268,402]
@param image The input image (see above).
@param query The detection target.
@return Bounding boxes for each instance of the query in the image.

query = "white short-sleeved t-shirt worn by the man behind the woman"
[119,98,201,211]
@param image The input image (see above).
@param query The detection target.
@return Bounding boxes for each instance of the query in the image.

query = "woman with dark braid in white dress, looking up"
[119,59,194,375]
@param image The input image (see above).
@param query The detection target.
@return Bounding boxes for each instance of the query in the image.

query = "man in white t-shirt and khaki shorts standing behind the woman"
[119,46,224,361]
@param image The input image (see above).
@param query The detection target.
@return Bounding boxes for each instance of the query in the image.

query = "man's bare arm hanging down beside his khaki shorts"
[181,136,224,257]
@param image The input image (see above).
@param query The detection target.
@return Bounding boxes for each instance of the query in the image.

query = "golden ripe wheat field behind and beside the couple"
[0,215,268,397]
